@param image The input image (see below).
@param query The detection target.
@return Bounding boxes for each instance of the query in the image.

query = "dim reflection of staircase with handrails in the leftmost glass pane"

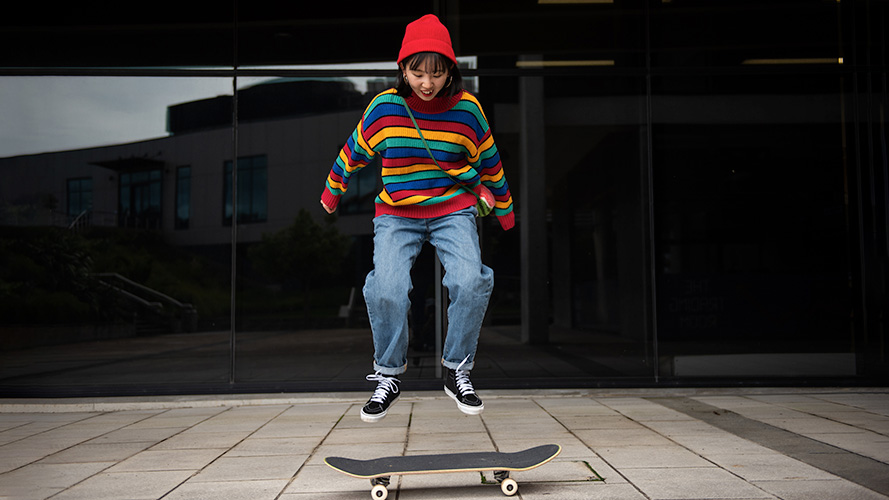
[92,273,198,335]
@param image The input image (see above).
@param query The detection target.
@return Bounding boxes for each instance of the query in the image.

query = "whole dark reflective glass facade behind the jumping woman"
[0,0,889,396]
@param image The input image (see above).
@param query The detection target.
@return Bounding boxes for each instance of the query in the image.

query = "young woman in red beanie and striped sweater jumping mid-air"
[321,14,515,422]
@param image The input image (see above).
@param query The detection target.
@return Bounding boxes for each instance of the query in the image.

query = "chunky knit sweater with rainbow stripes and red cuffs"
[321,89,515,230]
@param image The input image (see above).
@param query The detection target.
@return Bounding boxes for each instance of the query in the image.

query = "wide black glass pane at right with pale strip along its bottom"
[652,73,855,377]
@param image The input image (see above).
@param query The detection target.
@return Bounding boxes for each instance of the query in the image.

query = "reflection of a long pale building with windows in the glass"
[0,79,378,245]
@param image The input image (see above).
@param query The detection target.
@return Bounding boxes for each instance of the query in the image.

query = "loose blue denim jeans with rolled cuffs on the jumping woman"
[364,207,494,375]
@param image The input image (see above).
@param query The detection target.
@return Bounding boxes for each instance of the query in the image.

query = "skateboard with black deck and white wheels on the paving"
[324,444,562,500]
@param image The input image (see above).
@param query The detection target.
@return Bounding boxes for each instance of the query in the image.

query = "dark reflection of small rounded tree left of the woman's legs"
[248,210,352,315]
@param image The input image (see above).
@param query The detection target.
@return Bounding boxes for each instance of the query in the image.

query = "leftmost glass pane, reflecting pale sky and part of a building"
[0,76,232,394]
